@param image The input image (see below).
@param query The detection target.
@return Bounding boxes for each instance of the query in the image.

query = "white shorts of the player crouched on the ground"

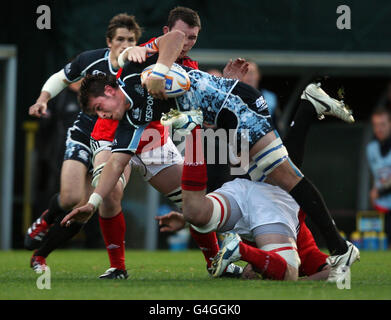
[214,178,300,241]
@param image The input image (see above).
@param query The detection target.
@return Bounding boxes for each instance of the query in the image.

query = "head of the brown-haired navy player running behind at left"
[106,13,142,59]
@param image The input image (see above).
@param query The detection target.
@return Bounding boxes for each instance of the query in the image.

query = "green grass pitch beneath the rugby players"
[0,250,391,300]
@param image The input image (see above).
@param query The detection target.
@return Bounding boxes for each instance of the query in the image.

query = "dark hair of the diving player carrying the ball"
[78,73,118,114]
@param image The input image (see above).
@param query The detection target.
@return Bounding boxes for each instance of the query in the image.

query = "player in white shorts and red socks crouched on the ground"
[155,123,300,280]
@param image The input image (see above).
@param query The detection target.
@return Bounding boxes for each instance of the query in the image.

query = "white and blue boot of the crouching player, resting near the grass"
[212,233,242,278]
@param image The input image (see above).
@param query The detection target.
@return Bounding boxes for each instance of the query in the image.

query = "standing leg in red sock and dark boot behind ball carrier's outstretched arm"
[93,148,130,279]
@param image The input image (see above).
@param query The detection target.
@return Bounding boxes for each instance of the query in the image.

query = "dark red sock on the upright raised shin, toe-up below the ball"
[182,126,208,191]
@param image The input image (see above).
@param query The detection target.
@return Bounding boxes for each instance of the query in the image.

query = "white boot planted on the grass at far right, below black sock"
[326,241,360,282]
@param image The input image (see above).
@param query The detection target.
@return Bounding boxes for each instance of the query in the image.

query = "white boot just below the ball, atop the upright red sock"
[160,109,204,136]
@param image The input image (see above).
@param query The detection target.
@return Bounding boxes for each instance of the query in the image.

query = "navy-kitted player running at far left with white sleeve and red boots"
[25,14,141,277]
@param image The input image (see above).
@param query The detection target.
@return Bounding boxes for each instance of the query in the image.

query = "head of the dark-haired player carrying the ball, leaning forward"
[79,74,129,120]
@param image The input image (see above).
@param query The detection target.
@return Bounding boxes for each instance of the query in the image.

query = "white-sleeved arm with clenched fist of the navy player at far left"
[29,69,70,118]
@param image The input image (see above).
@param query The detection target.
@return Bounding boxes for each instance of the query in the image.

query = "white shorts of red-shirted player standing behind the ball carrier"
[130,137,183,181]
